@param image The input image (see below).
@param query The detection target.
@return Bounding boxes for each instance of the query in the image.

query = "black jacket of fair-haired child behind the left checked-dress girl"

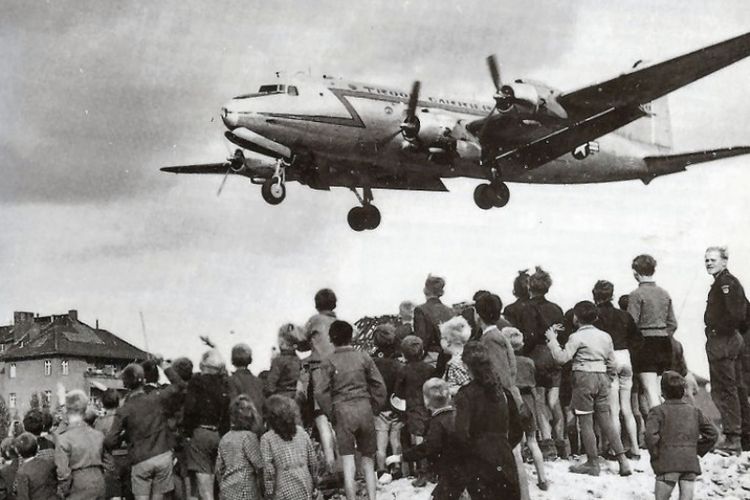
[182,373,229,435]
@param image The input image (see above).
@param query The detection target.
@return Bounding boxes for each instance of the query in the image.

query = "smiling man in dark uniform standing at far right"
[704,247,750,455]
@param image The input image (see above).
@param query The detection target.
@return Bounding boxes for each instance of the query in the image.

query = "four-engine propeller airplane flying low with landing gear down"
[161,33,750,231]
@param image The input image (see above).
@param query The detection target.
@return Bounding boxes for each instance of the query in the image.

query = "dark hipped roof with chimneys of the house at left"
[0,314,148,361]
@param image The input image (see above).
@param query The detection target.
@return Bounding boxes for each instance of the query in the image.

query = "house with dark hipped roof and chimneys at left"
[0,310,148,417]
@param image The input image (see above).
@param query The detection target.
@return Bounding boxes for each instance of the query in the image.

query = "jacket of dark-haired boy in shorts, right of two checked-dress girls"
[315,345,387,415]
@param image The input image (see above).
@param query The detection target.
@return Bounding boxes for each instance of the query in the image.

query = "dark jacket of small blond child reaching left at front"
[403,406,465,488]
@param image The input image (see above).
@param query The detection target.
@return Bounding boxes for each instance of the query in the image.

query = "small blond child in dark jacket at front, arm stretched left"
[388,378,471,500]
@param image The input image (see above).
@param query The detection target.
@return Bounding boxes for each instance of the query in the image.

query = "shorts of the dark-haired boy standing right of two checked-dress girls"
[333,399,377,458]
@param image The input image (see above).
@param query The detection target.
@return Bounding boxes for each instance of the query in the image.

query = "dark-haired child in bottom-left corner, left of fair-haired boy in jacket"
[16,432,58,500]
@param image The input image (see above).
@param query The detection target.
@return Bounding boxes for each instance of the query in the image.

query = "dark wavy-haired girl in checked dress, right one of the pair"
[260,395,317,500]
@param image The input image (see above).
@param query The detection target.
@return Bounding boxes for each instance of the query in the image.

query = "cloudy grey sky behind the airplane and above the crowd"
[0,0,750,375]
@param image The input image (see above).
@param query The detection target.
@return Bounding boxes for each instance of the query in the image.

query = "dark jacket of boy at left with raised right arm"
[104,385,183,464]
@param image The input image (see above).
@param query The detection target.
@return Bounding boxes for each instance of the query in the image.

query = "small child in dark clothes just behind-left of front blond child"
[395,335,435,487]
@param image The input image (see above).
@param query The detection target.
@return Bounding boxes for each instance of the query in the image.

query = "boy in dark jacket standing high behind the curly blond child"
[414,275,455,366]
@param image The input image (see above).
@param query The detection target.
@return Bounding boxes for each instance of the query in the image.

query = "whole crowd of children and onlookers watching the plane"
[0,247,750,500]
